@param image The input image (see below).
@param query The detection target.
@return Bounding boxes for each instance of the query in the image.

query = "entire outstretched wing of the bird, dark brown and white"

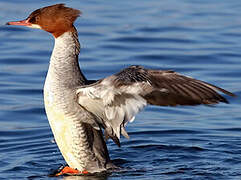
[77,66,234,144]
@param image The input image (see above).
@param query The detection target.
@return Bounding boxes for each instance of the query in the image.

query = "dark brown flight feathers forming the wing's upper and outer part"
[114,66,235,106]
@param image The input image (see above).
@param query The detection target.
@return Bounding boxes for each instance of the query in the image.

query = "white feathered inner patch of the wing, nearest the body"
[77,79,147,139]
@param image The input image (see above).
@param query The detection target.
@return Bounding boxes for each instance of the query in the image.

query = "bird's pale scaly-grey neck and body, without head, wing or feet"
[44,29,112,172]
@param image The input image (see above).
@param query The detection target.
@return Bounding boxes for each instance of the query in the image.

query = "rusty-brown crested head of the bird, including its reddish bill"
[7,4,81,38]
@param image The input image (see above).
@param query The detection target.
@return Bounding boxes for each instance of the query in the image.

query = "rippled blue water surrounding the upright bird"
[0,0,241,180]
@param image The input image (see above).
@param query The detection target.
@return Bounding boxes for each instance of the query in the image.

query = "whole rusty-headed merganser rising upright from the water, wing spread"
[6,4,235,176]
